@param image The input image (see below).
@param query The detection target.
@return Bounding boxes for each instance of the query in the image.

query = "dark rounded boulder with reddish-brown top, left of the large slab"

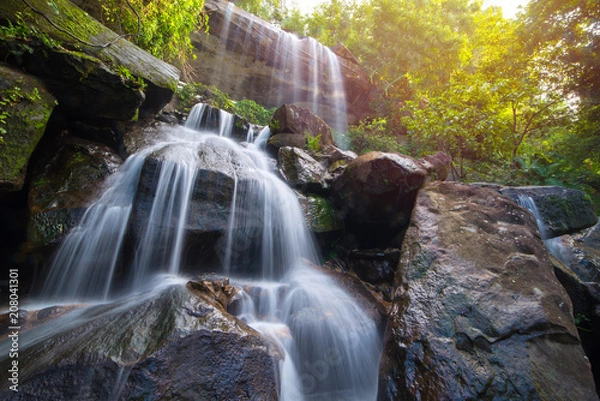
[331,152,427,247]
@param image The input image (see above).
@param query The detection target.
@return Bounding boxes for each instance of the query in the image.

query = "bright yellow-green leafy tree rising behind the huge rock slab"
[403,8,568,176]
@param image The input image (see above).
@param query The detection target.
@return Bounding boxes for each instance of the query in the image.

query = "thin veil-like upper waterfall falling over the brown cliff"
[210,3,348,142]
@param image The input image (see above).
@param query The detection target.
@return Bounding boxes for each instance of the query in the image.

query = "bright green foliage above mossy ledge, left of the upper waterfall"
[99,0,207,75]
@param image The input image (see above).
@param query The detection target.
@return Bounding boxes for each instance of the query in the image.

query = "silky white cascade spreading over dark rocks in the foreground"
[27,102,381,401]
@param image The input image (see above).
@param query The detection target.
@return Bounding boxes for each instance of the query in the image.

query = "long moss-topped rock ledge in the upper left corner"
[0,0,180,120]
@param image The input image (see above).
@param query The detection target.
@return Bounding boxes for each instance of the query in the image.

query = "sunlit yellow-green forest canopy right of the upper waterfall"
[252,0,600,203]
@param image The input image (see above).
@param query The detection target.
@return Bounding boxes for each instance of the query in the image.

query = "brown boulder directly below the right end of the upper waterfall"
[267,104,333,152]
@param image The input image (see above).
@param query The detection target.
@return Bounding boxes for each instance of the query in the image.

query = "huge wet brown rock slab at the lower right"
[379,182,598,400]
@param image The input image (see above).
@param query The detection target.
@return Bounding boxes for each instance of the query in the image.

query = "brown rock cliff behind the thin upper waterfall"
[190,0,376,127]
